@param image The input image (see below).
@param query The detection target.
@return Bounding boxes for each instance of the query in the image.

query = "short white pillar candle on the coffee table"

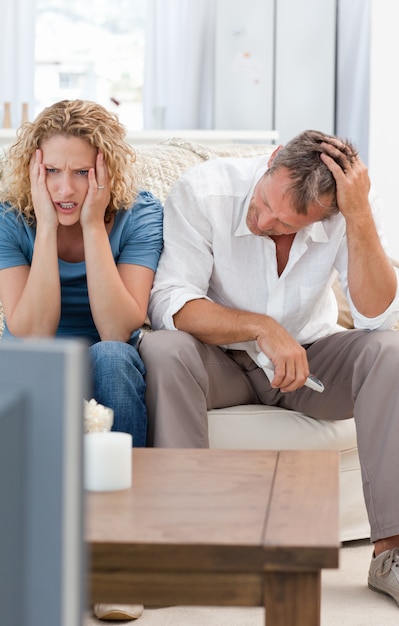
[84,432,132,491]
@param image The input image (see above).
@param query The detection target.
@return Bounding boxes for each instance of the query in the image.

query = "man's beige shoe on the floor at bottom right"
[368,548,399,606]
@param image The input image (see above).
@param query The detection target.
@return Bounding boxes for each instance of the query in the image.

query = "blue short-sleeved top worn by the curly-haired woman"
[0,191,163,343]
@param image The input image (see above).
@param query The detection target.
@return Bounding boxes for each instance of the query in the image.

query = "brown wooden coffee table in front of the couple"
[86,448,340,626]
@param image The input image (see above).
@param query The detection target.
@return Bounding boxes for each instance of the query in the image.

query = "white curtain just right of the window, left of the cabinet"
[143,0,215,129]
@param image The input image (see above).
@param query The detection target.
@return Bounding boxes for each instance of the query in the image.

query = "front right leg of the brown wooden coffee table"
[264,571,321,626]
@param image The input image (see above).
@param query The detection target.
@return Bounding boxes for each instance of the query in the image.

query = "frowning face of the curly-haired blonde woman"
[41,135,97,226]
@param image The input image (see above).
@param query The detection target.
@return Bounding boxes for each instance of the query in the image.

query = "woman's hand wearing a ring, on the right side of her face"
[80,152,111,228]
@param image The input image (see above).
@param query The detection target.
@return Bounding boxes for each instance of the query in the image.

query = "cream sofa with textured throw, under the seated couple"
[0,137,382,541]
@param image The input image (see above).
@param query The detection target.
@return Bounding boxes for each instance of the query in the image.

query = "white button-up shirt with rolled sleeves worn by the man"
[149,155,399,350]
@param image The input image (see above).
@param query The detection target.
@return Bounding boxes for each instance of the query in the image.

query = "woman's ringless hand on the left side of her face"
[29,148,58,228]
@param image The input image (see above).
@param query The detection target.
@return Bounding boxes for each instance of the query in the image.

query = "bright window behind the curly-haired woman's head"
[35,0,146,130]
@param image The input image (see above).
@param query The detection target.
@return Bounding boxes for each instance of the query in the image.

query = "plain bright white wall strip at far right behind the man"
[369,0,399,259]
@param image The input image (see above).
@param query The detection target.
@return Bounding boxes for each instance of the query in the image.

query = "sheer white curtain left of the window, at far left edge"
[0,0,36,127]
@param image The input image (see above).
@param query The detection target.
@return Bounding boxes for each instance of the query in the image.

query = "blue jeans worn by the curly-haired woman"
[89,341,147,448]
